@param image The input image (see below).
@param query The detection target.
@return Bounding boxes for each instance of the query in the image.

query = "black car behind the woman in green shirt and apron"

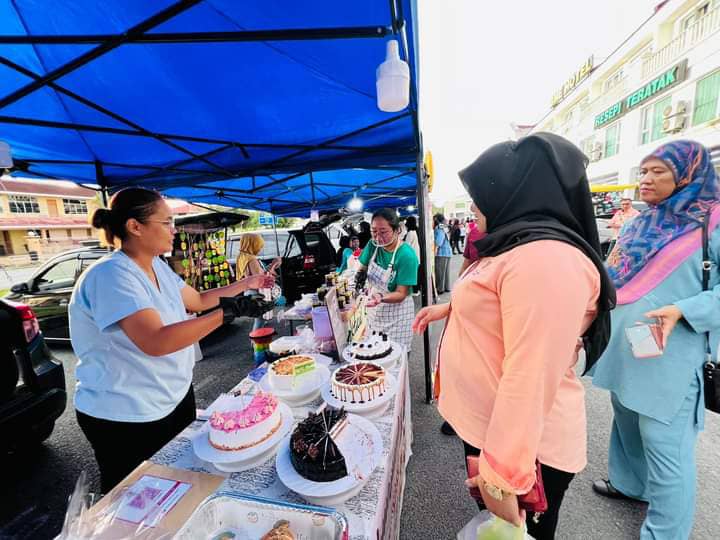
[227,222,336,303]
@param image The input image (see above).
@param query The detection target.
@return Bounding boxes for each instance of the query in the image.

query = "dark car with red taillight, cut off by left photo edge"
[0,299,67,453]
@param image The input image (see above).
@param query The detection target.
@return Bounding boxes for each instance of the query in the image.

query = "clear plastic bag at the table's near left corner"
[55,471,172,540]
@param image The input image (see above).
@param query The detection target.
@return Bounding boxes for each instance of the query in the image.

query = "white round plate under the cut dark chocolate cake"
[275,414,383,506]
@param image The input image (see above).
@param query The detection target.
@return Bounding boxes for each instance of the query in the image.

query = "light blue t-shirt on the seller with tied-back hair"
[69,250,195,422]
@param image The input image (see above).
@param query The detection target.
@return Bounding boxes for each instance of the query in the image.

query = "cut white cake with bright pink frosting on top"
[210,392,282,450]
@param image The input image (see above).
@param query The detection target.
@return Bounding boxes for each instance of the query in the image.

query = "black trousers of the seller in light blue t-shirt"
[75,385,196,493]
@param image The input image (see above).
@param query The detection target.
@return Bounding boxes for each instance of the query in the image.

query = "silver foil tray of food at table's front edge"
[174,491,349,540]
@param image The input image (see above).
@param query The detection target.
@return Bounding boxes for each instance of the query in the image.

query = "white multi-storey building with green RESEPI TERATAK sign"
[533,0,720,196]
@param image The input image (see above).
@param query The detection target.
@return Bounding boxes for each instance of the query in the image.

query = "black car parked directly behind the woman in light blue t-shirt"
[5,247,110,342]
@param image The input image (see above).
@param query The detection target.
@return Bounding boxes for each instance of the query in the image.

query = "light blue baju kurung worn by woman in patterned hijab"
[592,229,720,540]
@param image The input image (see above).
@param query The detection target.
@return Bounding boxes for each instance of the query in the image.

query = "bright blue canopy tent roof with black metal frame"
[0,0,429,395]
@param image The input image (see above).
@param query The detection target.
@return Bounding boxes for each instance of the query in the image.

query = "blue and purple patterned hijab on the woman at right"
[608,140,720,288]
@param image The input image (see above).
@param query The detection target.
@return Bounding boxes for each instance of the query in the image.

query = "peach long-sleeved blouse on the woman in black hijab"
[438,240,600,494]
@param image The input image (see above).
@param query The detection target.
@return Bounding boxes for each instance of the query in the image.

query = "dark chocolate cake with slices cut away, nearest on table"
[290,407,347,482]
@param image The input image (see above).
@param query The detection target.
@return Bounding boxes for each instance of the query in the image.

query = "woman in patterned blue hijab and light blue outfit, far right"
[592,140,720,540]
